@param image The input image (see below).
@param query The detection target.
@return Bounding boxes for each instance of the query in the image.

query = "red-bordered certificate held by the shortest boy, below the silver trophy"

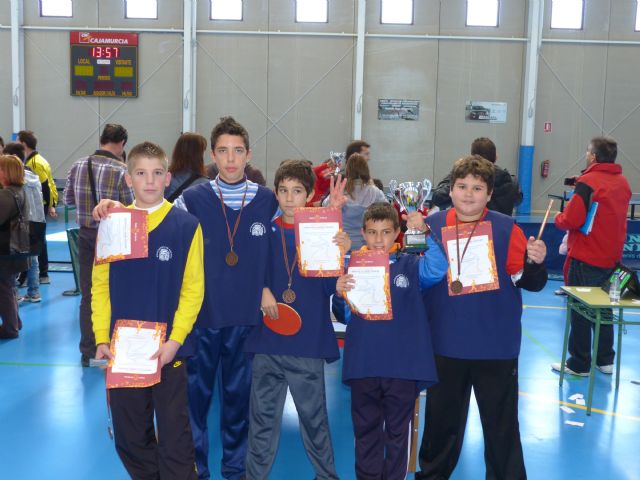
[345,251,393,320]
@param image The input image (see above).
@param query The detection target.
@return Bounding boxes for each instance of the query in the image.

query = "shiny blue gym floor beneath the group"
[0,215,640,480]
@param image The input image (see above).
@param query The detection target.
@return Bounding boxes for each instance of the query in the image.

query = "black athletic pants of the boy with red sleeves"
[416,356,527,480]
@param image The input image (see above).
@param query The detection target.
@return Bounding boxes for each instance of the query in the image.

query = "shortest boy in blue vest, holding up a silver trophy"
[336,202,447,480]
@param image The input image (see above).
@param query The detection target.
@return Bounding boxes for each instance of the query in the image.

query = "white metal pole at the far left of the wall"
[11,0,25,136]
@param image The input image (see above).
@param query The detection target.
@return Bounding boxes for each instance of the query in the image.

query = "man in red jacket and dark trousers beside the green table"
[551,137,631,376]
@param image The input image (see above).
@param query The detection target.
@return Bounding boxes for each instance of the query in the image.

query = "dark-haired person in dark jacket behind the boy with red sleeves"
[432,137,522,216]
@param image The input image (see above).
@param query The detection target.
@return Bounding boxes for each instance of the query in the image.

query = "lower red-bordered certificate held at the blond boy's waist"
[107,320,167,388]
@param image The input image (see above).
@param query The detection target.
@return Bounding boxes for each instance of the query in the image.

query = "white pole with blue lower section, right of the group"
[517,0,544,215]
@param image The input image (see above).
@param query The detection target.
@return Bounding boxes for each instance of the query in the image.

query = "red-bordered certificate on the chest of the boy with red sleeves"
[442,221,500,296]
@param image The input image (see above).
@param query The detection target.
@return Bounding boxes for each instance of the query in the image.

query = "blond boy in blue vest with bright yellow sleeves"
[91,142,204,479]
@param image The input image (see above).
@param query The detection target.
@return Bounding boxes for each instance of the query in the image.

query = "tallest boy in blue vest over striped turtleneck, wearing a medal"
[94,117,278,480]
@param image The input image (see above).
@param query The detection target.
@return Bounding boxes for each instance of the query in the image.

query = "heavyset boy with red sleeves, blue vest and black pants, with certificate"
[413,155,547,480]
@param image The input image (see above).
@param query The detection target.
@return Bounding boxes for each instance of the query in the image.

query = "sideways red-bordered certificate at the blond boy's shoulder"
[95,208,149,265]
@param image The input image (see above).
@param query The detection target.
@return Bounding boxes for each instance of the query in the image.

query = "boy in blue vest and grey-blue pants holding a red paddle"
[245,160,351,480]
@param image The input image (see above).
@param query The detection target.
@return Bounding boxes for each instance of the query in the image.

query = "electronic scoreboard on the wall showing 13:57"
[71,32,138,97]
